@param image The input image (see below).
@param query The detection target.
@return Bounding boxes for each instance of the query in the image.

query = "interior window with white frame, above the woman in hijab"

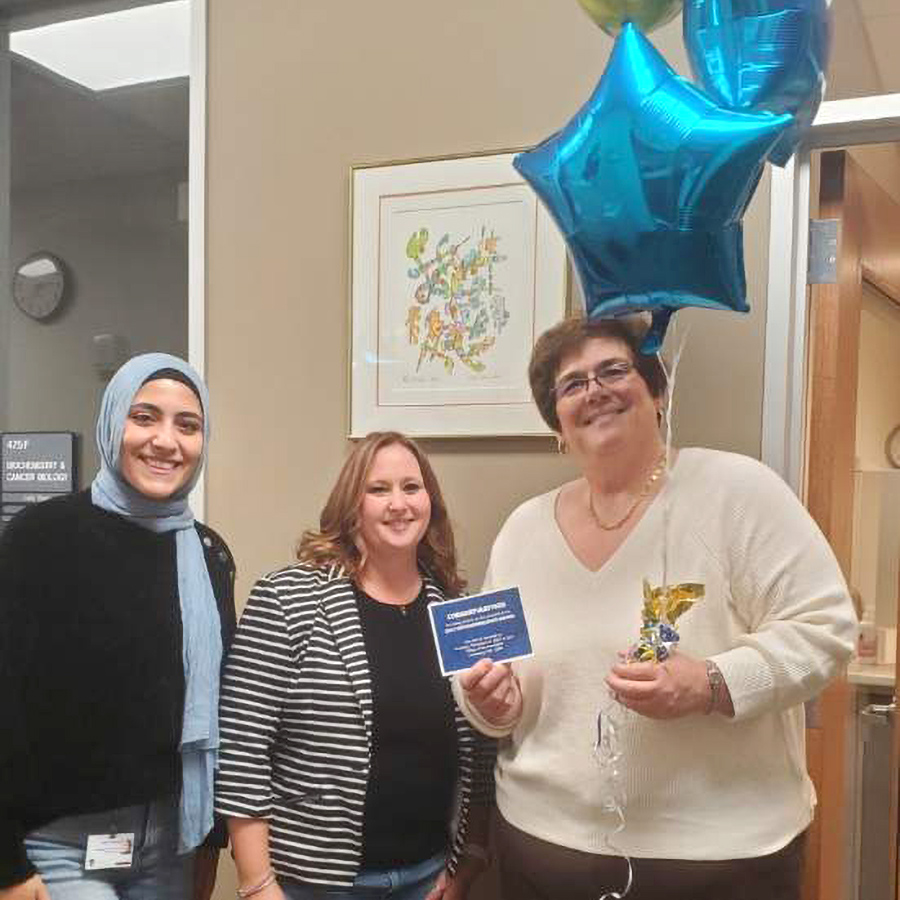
[0,0,200,492]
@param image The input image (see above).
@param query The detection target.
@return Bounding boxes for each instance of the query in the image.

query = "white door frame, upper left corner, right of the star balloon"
[761,93,900,488]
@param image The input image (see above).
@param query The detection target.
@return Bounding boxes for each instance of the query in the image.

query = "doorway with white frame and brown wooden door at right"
[763,95,900,900]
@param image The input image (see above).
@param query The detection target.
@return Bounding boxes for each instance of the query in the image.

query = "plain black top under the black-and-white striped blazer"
[356,587,458,869]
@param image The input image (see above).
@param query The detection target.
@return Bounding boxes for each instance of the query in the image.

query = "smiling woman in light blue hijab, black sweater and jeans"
[0,353,235,900]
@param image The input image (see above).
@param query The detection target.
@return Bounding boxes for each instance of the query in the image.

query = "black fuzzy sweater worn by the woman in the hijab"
[0,491,235,888]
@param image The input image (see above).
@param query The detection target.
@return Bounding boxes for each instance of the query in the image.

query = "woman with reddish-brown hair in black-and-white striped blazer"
[216,432,494,900]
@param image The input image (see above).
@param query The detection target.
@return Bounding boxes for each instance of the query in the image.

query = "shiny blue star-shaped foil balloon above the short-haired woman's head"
[514,24,791,352]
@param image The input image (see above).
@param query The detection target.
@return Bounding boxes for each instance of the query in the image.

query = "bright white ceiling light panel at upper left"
[9,0,191,91]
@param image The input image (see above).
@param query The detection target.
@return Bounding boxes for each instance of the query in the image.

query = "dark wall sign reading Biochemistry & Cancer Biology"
[0,431,78,527]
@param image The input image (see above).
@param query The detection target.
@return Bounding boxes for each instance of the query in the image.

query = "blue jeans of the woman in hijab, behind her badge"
[25,801,194,900]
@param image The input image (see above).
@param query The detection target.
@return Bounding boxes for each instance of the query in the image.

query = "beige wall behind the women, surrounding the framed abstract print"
[207,0,768,898]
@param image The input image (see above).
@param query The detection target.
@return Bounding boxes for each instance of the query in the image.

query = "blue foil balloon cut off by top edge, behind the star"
[683,0,831,166]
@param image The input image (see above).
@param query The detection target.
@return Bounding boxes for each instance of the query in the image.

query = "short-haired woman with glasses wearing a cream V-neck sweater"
[456,319,855,900]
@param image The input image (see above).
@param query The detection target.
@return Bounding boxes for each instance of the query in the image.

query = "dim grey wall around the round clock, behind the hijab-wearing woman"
[0,173,188,478]
